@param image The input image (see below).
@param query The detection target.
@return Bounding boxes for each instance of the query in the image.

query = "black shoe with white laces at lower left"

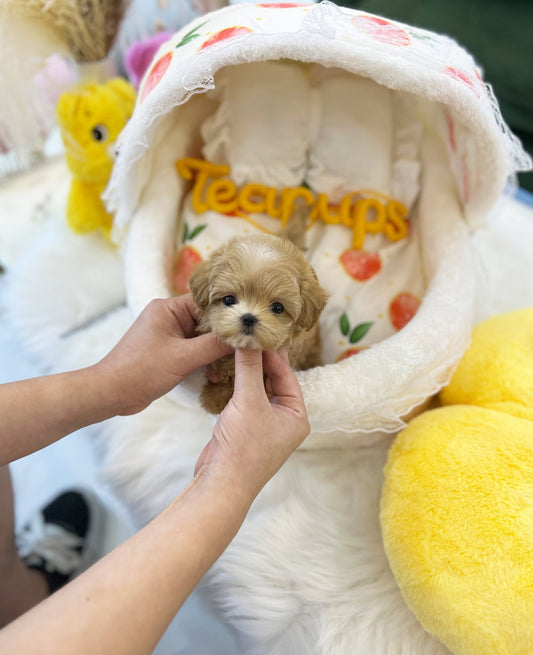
[15,490,103,593]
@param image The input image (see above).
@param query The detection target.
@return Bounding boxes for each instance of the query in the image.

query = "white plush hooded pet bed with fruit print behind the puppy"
[108,3,527,448]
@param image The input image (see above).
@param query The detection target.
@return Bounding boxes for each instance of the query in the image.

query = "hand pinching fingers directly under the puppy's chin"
[196,350,310,502]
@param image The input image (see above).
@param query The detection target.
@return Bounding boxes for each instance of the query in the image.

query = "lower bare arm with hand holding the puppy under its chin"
[0,351,309,655]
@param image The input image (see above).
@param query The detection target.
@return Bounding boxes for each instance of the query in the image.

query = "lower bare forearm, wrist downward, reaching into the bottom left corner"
[0,474,249,655]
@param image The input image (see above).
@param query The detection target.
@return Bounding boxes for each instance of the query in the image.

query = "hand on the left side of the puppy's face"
[96,295,233,415]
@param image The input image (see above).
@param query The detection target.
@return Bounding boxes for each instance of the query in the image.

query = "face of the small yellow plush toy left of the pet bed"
[57,78,135,184]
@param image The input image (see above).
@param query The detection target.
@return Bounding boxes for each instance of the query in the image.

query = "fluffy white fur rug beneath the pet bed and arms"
[0,160,533,655]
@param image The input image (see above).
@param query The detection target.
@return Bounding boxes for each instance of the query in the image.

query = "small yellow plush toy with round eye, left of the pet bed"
[57,78,136,240]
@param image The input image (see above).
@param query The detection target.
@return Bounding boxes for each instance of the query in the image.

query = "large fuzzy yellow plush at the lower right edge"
[381,309,533,655]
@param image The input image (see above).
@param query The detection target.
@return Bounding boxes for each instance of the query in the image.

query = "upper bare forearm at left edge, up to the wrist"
[0,365,119,465]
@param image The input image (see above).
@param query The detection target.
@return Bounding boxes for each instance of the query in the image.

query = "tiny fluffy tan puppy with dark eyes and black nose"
[189,235,327,414]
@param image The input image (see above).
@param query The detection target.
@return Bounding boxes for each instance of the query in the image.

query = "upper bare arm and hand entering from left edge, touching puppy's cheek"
[0,296,231,466]
